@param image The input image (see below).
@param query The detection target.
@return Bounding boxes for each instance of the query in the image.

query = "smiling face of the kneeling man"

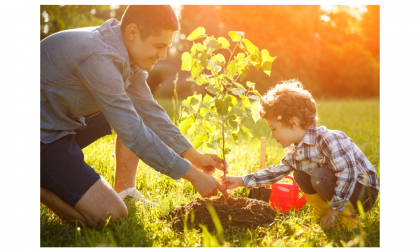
[127,30,175,72]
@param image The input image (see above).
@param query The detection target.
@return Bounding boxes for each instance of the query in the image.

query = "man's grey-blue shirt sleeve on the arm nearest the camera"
[78,54,190,179]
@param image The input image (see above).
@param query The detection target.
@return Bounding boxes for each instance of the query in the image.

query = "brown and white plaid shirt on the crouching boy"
[242,126,379,211]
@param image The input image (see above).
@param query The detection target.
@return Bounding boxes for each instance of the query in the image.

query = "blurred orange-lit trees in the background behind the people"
[40,5,380,98]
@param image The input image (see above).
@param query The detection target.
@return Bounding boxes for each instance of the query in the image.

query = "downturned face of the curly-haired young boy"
[264,118,306,148]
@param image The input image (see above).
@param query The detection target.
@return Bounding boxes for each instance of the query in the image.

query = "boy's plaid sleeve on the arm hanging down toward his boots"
[319,134,357,212]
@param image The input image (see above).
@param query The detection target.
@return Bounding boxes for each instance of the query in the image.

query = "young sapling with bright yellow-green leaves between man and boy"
[179,27,276,191]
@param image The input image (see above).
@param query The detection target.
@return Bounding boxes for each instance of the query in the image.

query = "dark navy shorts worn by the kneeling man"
[41,112,112,207]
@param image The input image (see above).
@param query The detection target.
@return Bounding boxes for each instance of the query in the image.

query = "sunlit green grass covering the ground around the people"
[40,99,380,247]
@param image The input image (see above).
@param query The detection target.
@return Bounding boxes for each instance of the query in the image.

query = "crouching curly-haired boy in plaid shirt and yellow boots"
[221,80,379,228]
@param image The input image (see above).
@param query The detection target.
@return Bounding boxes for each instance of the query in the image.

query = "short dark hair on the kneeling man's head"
[121,5,180,41]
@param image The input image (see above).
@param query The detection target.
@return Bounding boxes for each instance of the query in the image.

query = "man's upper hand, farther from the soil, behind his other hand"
[181,148,229,175]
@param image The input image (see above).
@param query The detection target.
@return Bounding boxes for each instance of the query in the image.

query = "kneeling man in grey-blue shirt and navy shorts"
[41,6,229,226]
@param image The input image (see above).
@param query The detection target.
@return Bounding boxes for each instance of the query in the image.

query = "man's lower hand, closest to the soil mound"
[182,165,230,199]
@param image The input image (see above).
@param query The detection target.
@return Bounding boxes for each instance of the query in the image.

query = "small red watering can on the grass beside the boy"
[270,176,306,212]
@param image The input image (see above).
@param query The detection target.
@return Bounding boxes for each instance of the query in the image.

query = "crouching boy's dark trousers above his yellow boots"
[293,168,378,212]
